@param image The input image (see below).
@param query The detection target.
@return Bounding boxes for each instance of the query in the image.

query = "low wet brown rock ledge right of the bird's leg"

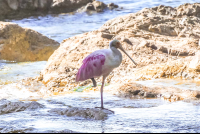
[116,82,200,102]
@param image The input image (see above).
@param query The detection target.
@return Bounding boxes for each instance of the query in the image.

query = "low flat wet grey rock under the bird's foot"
[49,107,113,120]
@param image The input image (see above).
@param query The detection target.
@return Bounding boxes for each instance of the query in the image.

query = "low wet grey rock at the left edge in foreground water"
[0,99,44,114]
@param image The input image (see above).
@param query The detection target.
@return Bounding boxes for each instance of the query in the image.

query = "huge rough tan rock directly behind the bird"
[29,3,200,99]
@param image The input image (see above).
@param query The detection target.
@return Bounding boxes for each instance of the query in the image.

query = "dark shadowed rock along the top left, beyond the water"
[0,0,118,20]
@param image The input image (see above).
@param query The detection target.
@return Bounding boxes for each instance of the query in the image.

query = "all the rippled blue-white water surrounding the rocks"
[0,0,200,133]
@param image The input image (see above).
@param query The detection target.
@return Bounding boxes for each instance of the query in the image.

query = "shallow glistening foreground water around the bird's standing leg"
[0,92,200,133]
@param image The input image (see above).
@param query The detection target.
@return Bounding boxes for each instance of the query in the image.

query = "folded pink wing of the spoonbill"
[76,51,106,81]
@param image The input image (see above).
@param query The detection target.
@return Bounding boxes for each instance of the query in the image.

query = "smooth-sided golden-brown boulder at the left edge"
[0,22,59,61]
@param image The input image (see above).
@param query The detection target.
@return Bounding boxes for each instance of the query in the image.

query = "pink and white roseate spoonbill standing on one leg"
[76,40,137,109]
